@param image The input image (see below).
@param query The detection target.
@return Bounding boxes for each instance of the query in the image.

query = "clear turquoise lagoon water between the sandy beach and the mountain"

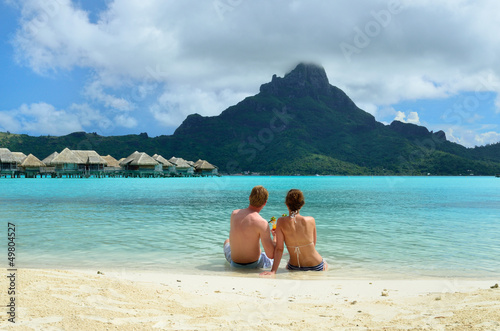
[0,176,500,278]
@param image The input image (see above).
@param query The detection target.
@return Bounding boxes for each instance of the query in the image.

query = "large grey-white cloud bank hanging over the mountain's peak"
[3,0,500,143]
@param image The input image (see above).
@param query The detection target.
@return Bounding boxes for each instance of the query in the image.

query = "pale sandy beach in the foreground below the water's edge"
[0,269,500,330]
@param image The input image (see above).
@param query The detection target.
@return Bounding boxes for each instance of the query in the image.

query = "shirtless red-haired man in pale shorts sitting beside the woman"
[224,185,276,269]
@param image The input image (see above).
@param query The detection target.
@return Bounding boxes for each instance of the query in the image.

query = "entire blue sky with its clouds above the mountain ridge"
[0,0,500,147]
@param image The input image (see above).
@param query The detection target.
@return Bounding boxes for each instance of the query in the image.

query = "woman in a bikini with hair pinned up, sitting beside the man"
[261,189,328,275]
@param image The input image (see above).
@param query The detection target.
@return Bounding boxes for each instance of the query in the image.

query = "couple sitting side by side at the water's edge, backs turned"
[224,185,328,275]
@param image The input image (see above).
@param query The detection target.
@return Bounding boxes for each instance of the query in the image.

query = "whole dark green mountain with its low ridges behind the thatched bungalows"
[0,64,500,175]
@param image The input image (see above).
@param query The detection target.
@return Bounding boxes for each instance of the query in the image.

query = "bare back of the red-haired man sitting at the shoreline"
[229,208,269,264]
